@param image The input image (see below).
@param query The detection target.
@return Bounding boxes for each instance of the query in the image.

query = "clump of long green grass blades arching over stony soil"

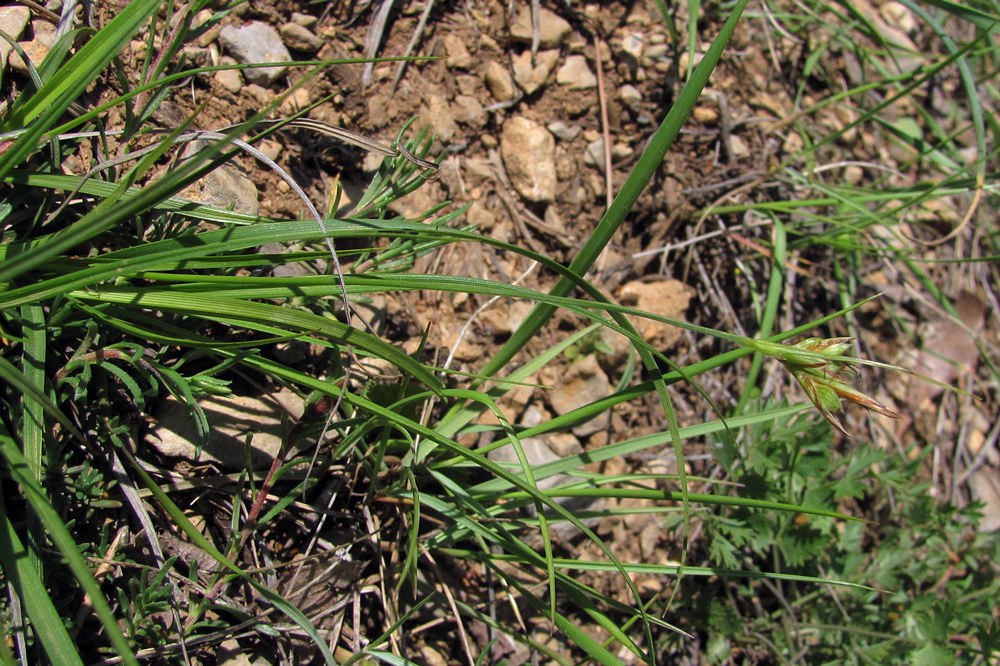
[0,0,987,663]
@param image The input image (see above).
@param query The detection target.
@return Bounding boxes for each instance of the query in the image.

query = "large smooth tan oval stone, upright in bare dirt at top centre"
[500,116,556,203]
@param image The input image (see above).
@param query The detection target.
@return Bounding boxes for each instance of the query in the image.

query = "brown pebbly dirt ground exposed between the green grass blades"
[66,0,991,663]
